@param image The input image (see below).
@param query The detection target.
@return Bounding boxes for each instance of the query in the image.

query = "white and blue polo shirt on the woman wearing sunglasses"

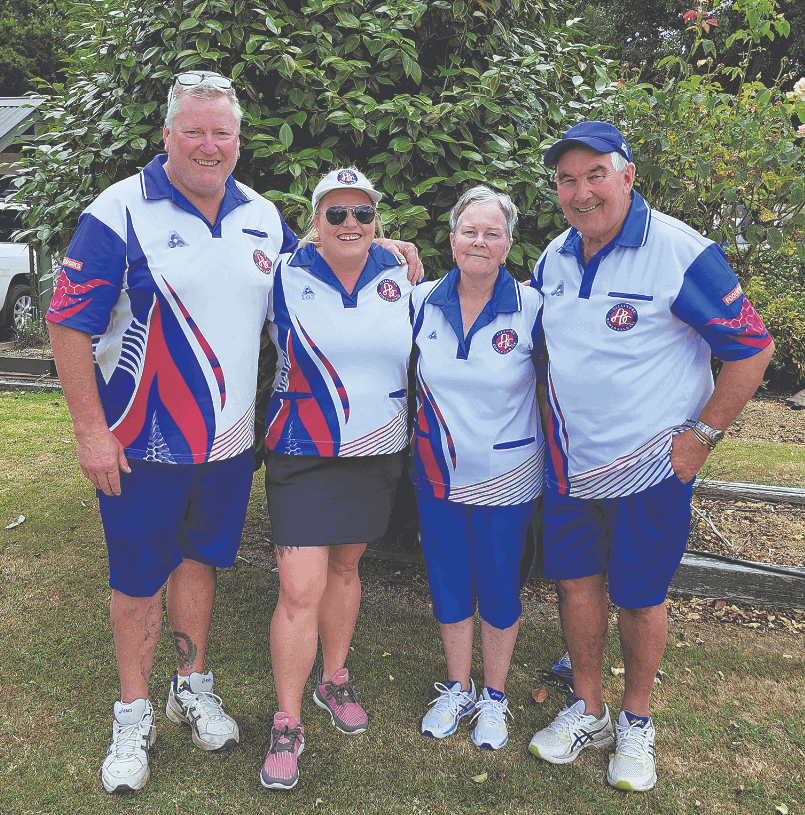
[266,243,413,457]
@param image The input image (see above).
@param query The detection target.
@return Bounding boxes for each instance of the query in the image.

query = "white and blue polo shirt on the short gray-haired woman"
[411,266,544,506]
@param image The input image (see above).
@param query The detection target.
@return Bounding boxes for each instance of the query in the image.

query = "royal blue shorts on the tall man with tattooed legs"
[98,449,254,597]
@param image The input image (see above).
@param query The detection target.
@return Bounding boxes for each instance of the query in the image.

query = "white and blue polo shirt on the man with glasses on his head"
[47,155,297,464]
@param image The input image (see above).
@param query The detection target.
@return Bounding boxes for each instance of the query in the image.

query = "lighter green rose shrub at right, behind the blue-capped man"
[593,0,805,280]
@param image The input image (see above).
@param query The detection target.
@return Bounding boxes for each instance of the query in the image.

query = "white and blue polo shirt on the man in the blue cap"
[532,192,771,498]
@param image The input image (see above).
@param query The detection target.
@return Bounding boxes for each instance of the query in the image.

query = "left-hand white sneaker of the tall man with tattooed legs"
[101,699,157,792]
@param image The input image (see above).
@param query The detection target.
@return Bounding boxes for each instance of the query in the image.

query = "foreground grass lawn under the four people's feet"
[0,393,805,815]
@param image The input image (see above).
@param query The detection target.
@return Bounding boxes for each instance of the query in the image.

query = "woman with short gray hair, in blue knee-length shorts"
[411,186,544,750]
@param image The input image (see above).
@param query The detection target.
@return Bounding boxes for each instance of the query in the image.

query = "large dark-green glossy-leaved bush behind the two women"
[11,0,606,284]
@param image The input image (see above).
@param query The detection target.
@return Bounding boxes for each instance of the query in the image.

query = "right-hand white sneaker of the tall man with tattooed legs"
[165,671,240,751]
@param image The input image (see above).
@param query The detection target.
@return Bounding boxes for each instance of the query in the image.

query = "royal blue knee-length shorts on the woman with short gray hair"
[416,490,534,629]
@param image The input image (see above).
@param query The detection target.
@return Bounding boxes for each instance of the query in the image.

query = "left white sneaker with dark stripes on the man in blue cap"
[528,696,615,764]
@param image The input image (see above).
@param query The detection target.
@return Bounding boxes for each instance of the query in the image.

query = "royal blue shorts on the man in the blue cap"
[543,475,693,608]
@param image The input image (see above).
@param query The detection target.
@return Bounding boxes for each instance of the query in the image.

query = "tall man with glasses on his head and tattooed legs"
[47,72,415,792]
